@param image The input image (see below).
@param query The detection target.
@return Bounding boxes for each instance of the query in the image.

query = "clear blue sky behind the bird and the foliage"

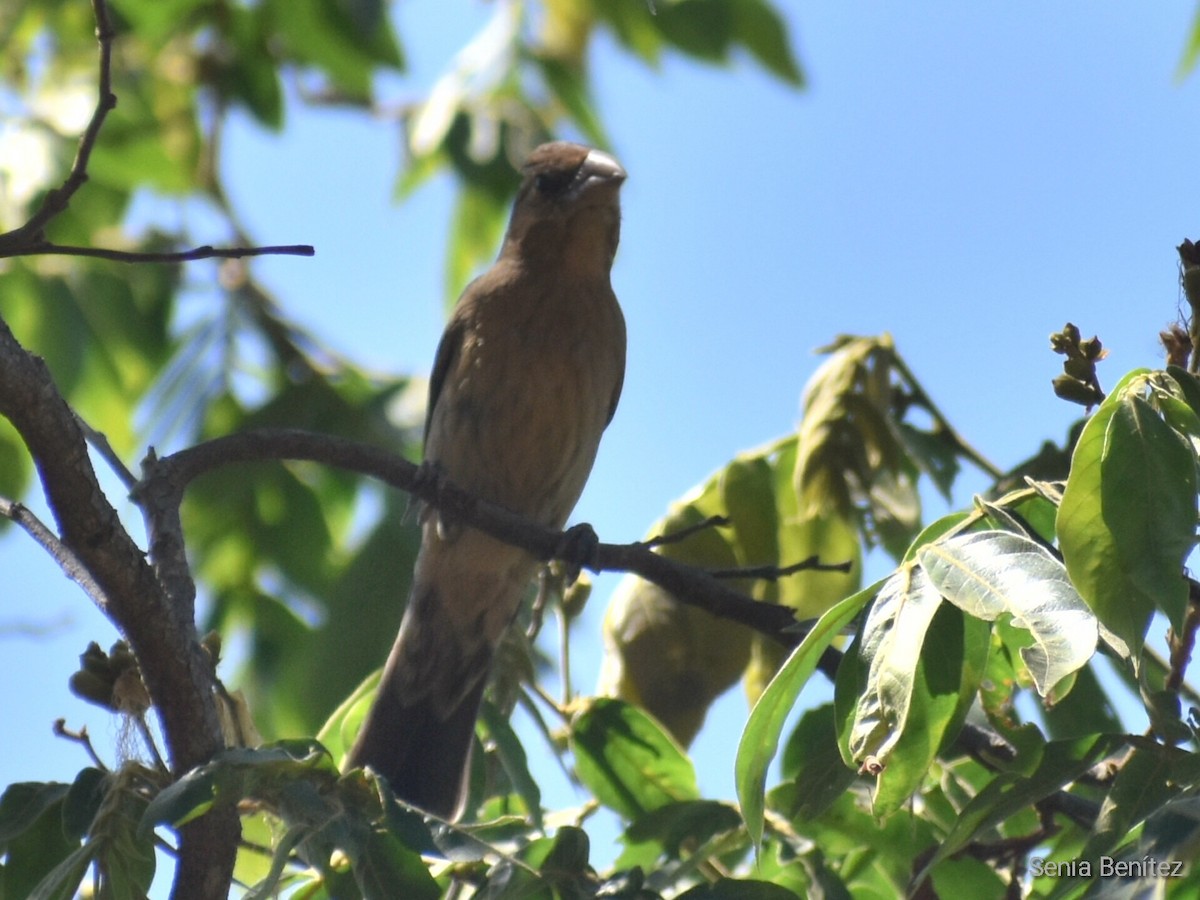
[7,0,1200,888]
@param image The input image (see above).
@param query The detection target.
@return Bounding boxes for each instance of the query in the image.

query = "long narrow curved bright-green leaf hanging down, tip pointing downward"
[734,584,878,851]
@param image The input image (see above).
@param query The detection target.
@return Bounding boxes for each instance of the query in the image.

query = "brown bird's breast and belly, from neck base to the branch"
[426,278,625,527]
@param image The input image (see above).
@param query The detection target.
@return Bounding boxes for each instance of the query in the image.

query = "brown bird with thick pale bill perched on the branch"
[347,142,625,818]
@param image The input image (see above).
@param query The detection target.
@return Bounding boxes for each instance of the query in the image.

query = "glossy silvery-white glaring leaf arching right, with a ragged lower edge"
[917,532,1099,697]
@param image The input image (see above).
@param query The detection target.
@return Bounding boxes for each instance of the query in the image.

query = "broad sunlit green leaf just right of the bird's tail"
[571,697,700,820]
